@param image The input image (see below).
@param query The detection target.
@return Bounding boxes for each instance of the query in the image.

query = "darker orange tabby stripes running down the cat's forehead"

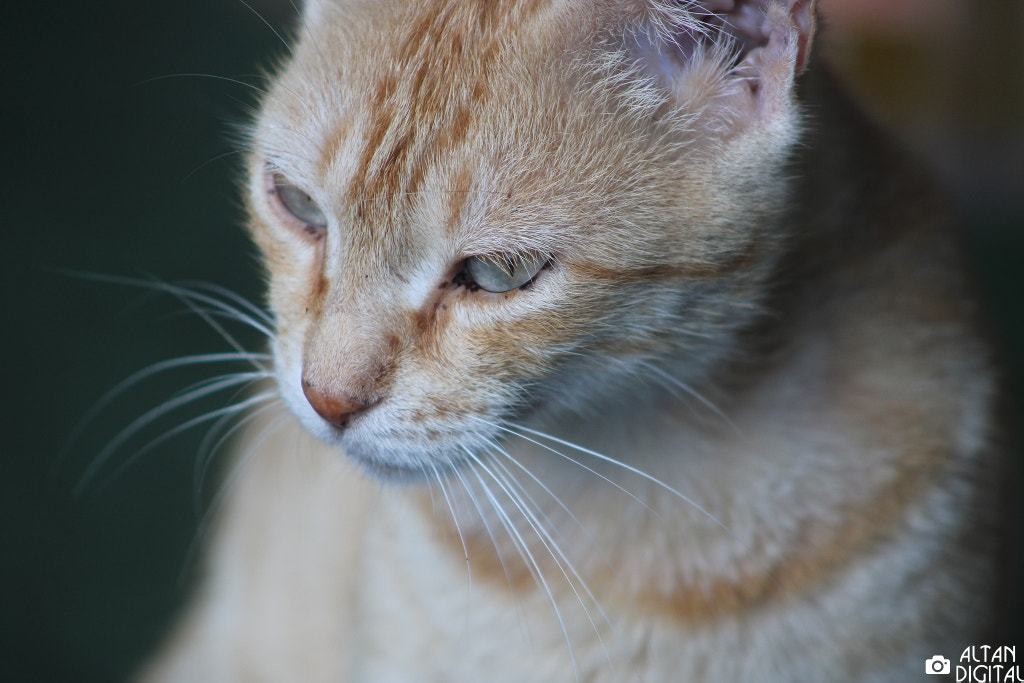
[349,0,542,216]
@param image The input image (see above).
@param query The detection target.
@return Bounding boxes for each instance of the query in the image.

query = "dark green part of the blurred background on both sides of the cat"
[0,0,1024,681]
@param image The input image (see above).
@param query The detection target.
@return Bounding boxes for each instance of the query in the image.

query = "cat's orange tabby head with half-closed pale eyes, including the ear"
[241,0,814,473]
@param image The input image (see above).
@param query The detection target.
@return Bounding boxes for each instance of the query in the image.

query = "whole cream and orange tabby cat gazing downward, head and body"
[134,0,1000,681]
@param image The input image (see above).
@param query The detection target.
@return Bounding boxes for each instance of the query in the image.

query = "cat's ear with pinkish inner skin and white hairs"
[628,0,816,125]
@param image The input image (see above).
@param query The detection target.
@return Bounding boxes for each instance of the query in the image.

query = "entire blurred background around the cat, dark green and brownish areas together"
[0,0,1024,681]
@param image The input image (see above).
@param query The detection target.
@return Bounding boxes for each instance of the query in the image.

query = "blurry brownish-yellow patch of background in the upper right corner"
[818,0,1024,204]
